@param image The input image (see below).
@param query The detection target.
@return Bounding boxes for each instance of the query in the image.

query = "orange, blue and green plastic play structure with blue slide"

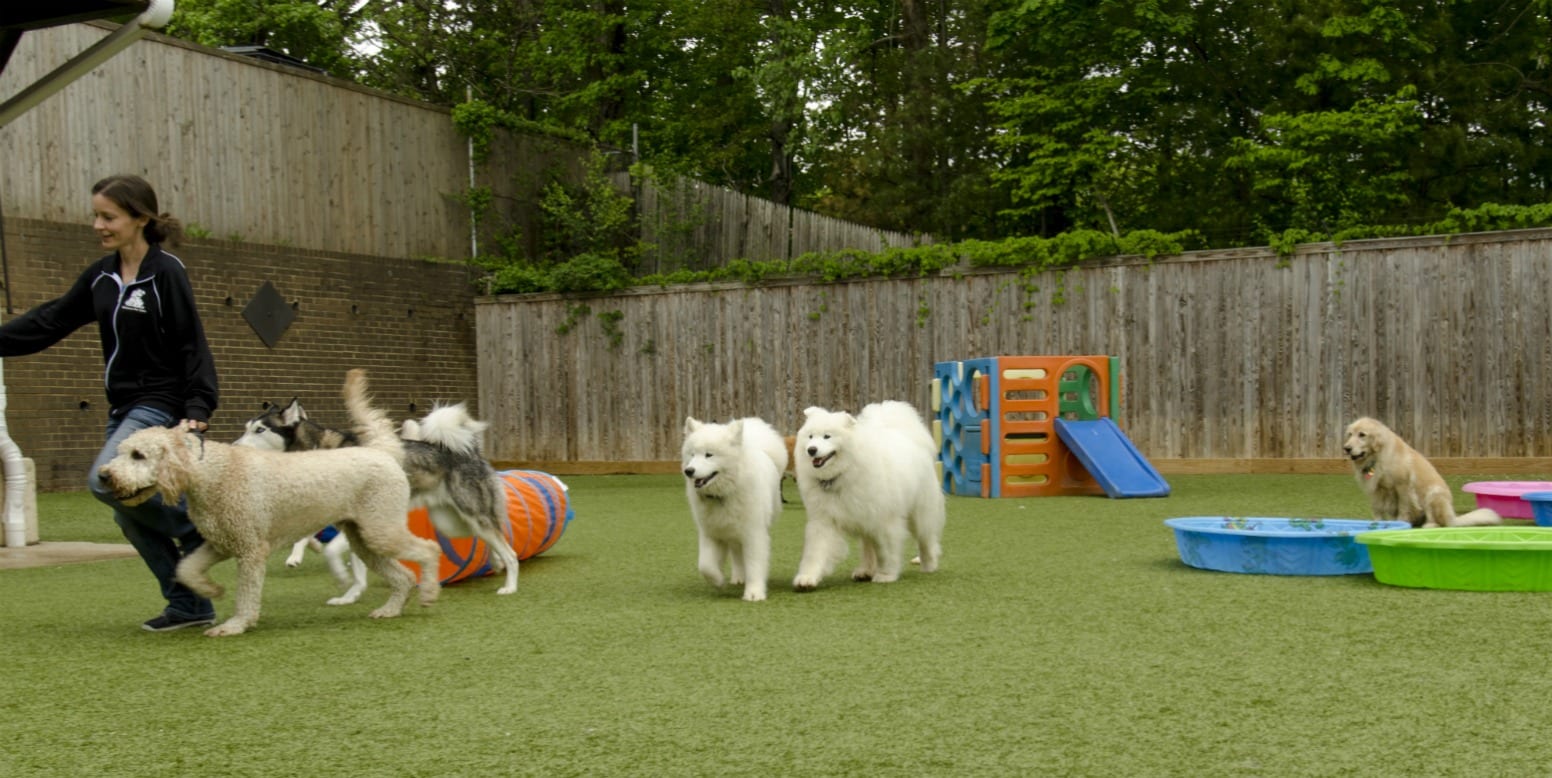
[933,356,1169,498]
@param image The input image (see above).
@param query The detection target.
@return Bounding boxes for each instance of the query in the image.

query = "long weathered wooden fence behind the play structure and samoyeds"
[475,230,1552,472]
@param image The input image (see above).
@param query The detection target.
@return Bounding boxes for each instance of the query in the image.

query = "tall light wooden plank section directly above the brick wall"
[0,25,470,258]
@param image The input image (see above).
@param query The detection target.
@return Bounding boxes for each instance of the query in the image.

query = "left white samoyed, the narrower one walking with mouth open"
[681,416,787,603]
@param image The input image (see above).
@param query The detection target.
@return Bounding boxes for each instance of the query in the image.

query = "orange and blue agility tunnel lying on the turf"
[405,471,571,584]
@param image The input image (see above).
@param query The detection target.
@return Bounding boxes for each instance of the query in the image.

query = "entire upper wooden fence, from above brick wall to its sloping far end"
[0,23,923,270]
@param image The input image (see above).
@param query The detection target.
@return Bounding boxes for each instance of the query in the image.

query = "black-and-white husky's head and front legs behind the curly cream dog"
[233,398,366,606]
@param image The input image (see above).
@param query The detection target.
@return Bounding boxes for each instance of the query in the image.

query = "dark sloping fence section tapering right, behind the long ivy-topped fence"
[611,172,933,272]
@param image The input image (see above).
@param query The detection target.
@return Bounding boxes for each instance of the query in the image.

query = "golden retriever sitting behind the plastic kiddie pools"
[1342,416,1504,526]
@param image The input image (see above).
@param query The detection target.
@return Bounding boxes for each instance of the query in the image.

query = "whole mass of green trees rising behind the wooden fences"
[171,0,1552,253]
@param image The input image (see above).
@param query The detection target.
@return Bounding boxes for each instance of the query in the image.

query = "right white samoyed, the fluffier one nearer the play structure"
[792,401,944,592]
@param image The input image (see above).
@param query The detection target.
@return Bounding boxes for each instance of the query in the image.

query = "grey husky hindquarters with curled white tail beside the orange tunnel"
[399,402,517,595]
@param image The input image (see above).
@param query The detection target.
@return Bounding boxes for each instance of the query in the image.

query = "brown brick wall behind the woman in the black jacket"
[3,219,478,491]
